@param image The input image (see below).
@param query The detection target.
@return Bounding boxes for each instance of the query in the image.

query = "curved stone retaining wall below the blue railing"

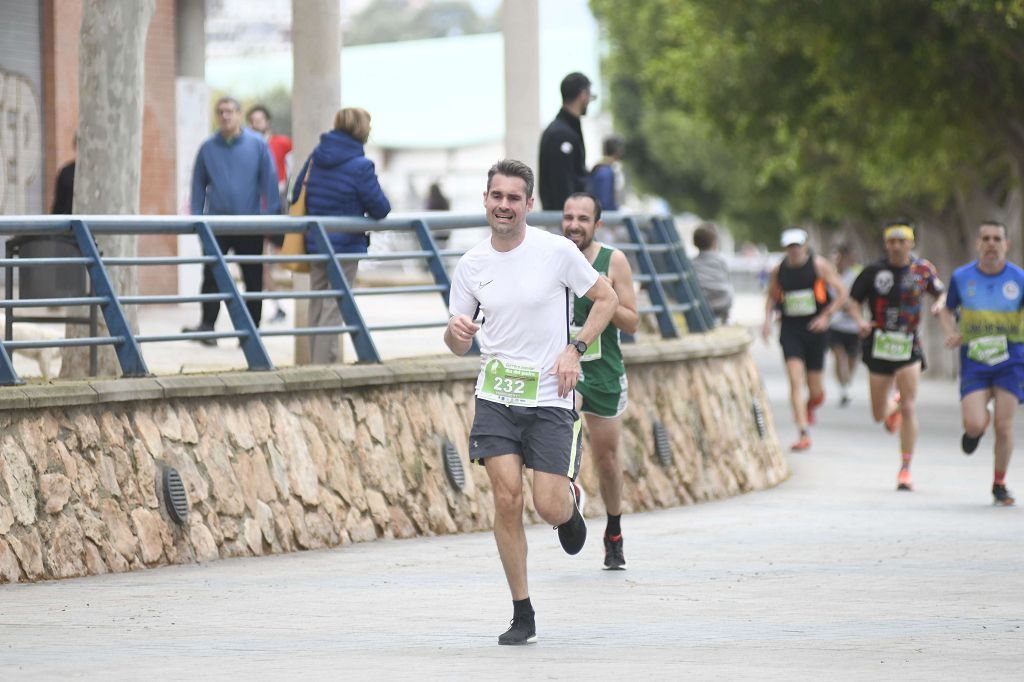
[0,329,788,583]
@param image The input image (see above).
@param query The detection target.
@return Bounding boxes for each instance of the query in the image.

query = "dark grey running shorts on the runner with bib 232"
[469,398,582,480]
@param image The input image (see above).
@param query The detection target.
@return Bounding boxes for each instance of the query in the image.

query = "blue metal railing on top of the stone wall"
[0,212,714,385]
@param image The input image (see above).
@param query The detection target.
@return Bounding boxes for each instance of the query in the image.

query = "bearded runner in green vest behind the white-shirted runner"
[562,193,640,570]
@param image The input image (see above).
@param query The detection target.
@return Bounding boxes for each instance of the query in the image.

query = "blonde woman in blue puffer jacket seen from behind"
[292,108,391,365]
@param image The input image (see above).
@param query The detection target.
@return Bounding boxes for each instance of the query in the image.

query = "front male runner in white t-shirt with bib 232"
[444,160,618,644]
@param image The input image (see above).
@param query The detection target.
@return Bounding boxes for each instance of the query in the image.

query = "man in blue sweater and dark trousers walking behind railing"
[181,97,281,339]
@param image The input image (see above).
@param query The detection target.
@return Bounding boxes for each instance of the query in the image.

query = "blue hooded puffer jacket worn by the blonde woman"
[292,130,391,253]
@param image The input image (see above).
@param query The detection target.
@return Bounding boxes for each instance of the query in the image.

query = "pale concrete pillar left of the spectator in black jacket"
[502,0,541,172]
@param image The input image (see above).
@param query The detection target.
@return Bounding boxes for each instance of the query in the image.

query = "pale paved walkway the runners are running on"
[0,337,1024,680]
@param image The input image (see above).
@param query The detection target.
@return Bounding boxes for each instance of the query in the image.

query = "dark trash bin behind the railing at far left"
[8,237,89,299]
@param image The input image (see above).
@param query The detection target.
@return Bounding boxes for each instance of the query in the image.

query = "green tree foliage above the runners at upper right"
[591,0,1024,246]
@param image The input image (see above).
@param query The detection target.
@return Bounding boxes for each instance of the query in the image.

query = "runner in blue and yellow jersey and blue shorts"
[941,221,1024,507]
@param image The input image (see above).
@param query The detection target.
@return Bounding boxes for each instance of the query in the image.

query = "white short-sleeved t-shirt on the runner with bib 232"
[449,225,598,410]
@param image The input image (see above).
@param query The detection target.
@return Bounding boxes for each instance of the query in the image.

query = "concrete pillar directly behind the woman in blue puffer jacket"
[292,0,341,365]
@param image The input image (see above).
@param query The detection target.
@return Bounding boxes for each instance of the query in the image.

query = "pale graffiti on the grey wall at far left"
[0,68,42,214]
